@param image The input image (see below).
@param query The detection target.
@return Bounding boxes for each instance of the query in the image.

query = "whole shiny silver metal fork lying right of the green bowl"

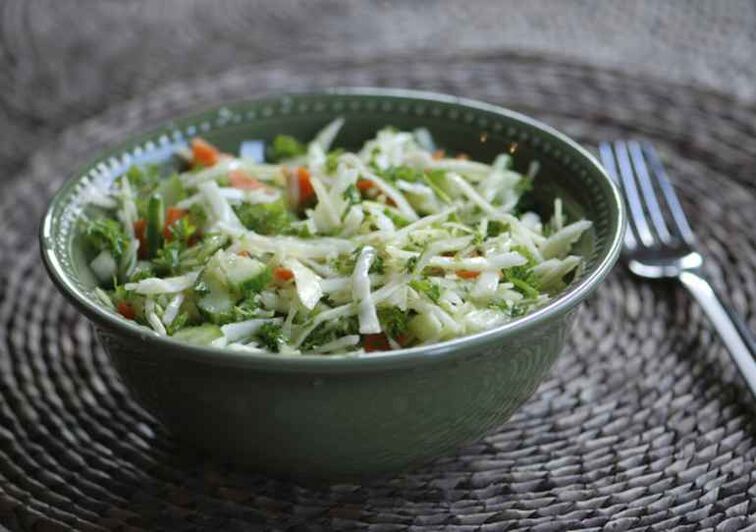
[599,140,756,397]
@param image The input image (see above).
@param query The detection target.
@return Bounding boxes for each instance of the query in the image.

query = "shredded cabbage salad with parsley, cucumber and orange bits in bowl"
[82,119,591,355]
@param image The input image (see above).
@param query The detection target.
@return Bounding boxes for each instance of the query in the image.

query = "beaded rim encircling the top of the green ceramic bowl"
[39,87,626,372]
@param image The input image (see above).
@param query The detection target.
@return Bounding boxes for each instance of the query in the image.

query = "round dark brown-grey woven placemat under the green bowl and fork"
[0,55,756,531]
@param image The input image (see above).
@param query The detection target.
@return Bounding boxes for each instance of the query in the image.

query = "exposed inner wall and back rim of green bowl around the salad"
[41,89,623,368]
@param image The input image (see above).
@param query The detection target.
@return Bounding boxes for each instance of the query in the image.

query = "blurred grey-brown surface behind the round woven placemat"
[0,0,756,179]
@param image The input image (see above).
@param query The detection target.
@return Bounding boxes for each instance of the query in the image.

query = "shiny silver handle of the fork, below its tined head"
[680,271,756,397]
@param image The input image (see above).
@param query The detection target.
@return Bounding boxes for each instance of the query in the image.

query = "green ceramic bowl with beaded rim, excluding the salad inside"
[40,89,624,480]
